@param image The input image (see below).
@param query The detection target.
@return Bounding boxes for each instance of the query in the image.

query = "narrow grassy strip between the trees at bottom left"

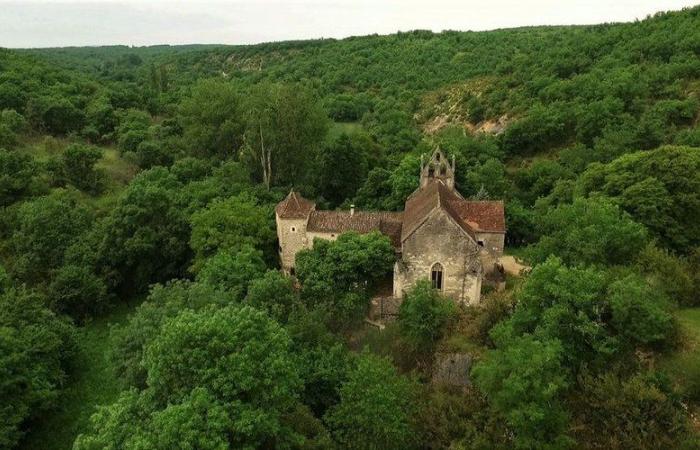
[20,305,133,450]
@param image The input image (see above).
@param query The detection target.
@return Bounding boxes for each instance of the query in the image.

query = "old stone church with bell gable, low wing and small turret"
[275,150,505,304]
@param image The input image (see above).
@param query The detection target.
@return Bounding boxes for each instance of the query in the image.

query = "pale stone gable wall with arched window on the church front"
[394,209,482,304]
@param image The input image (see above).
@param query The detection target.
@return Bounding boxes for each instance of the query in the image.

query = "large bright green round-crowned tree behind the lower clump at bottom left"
[143,307,300,446]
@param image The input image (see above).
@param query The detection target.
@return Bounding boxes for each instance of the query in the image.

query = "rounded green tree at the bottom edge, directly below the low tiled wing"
[325,352,418,450]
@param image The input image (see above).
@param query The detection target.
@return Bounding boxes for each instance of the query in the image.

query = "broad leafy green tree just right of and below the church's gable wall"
[497,258,675,372]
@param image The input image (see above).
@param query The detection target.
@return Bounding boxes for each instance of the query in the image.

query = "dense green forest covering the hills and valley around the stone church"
[0,7,700,450]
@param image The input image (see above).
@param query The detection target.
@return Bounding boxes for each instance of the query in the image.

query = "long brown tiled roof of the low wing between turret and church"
[306,211,403,247]
